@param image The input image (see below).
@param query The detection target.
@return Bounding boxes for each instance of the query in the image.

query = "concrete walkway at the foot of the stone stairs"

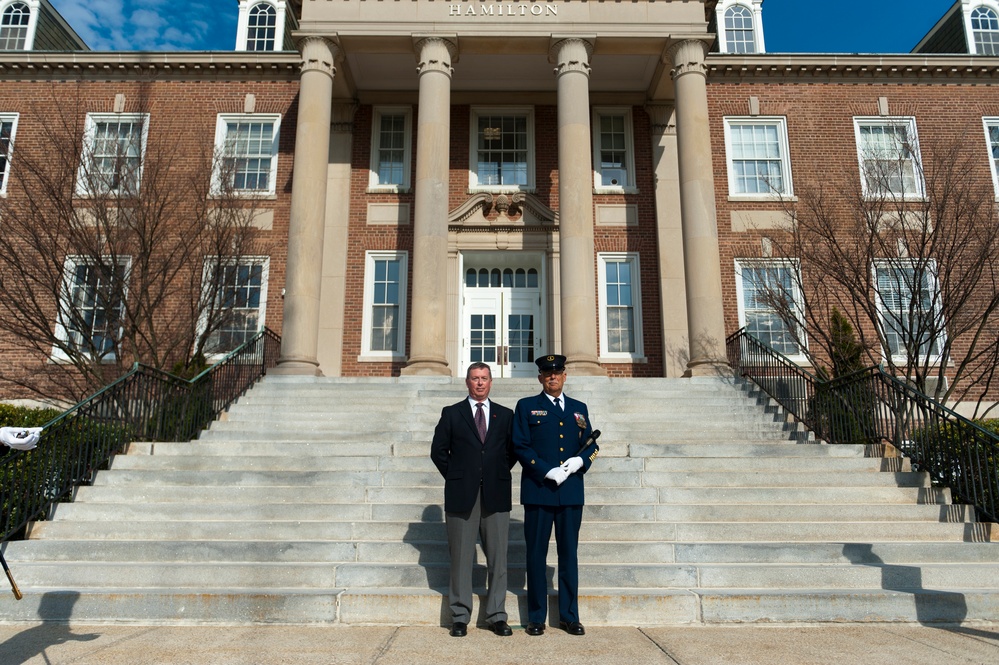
[0,623,999,665]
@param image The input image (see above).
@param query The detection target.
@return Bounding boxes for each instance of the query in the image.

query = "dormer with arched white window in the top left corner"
[0,0,90,51]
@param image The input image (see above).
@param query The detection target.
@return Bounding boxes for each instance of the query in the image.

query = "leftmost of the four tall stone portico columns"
[275,37,340,375]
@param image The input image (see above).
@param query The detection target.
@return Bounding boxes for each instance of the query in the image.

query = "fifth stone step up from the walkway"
[48,498,975,533]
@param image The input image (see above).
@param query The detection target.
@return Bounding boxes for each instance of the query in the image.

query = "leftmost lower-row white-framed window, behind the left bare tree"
[52,256,132,361]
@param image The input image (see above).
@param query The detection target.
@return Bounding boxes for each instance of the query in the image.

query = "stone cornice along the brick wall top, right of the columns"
[705,53,999,84]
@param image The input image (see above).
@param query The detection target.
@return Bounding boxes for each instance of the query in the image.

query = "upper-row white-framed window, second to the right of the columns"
[853,117,925,199]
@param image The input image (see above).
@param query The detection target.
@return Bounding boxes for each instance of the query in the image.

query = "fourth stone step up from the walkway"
[31,519,999,543]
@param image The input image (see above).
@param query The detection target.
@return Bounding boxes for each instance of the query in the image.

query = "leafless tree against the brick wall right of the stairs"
[744,125,999,416]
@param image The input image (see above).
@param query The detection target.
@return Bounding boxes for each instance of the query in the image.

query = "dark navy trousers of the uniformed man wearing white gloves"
[524,505,583,624]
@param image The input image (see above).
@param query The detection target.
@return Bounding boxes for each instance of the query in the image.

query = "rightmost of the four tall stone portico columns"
[668,39,731,376]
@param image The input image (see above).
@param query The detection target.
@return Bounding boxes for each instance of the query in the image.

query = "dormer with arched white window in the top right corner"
[912,0,999,56]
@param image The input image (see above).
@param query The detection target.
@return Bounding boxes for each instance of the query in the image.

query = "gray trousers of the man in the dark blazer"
[444,492,510,623]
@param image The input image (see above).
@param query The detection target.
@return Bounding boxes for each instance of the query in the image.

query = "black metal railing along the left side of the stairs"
[0,329,280,542]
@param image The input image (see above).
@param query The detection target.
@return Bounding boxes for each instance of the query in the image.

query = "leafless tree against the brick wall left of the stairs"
[0,84,265,399]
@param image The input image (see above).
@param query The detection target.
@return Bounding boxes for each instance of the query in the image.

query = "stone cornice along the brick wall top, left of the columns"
[0,51,302,80]
